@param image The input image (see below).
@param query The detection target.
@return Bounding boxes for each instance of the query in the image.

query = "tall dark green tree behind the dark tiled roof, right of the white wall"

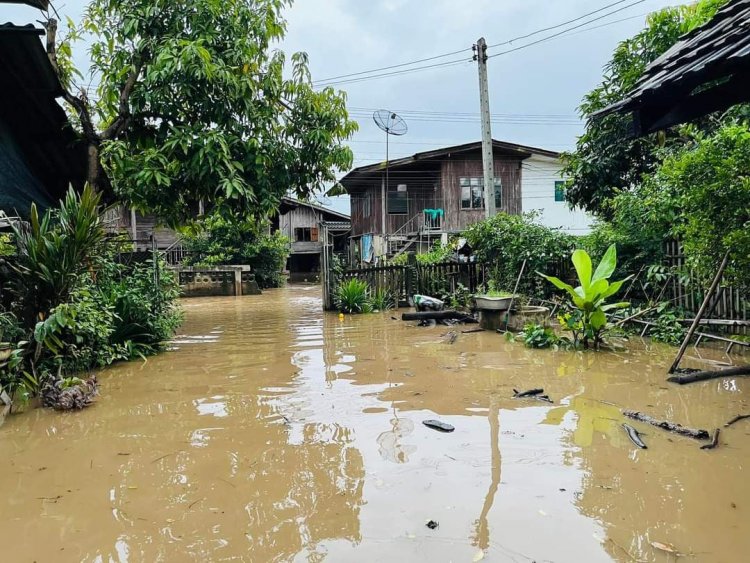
[563,0,727,218]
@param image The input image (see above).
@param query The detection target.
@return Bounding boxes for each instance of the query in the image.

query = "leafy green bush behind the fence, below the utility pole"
[465,213,575,297]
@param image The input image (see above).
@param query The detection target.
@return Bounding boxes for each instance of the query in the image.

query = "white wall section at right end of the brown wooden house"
[521,155,593,235]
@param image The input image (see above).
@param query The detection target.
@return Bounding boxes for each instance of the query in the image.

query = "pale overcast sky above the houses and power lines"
[0,0,680,209]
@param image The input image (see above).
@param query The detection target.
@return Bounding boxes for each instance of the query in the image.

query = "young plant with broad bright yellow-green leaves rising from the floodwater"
[537,244,633,348]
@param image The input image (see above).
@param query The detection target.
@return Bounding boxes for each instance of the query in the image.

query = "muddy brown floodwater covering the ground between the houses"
[0,287,750,562]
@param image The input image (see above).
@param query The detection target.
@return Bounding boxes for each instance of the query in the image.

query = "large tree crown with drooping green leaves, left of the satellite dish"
[48,0,356,223]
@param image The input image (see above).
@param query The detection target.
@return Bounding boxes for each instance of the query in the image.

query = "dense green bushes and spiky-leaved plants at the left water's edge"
[0,193,181,401]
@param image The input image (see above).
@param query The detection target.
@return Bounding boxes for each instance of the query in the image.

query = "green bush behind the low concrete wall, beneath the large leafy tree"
[185,211,290,288]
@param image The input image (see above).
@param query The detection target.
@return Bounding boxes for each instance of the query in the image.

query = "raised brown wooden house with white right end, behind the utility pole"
[340,141,591,262]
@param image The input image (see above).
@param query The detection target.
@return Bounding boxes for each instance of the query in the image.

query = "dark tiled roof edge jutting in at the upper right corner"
[594,0,750,134]
